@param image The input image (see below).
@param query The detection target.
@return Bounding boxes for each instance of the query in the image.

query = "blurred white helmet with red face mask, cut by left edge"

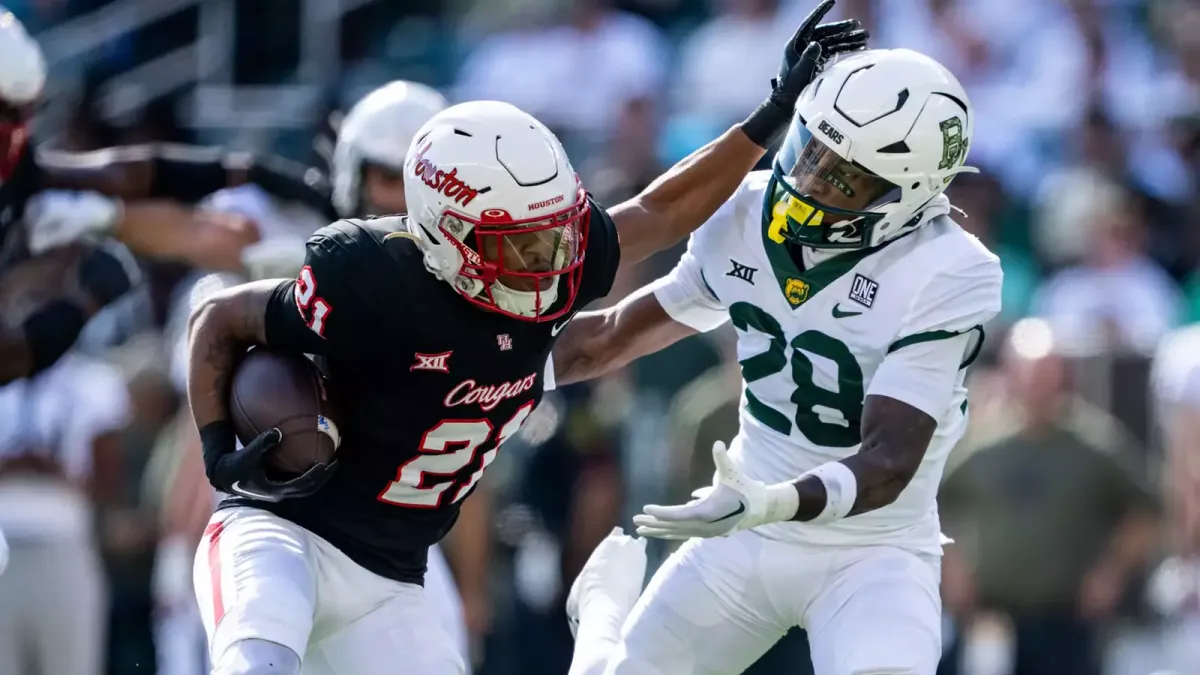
[0,7,46,181]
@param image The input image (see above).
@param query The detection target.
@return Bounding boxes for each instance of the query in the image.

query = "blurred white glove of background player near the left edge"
[24,190,125,255]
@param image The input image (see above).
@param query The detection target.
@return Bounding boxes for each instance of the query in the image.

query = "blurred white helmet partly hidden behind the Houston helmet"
[331,80,448,217]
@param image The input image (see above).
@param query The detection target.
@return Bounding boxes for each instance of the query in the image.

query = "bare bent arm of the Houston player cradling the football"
[187,280,280,429]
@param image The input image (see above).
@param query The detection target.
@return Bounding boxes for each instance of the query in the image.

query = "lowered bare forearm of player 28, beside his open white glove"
[792,396,937,521]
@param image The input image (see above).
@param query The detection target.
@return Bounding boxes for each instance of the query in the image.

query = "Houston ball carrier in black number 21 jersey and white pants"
[188,0,865,675]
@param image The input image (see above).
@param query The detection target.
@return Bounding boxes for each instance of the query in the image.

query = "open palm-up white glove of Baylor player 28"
[634,441,799,539]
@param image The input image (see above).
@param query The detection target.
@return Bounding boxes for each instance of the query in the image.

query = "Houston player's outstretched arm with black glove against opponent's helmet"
[610,0,868,263]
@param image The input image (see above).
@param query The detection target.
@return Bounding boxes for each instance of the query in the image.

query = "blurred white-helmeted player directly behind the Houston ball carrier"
[158,82,490,675]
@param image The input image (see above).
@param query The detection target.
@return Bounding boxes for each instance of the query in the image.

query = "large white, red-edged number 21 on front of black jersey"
[379,401,534,508]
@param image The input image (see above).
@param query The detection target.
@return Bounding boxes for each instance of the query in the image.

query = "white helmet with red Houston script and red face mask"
[404,101,589,321]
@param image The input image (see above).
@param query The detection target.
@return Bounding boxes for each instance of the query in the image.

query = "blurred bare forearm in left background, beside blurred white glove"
[114,201,258,271]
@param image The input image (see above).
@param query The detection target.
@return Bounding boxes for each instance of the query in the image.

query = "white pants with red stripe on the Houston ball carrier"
[194,507,464,675]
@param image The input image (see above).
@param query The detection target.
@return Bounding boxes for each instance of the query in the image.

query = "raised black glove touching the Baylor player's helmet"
[742,0,870,148]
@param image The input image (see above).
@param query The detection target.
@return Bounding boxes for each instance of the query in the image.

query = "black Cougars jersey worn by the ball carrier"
[222,196,620,583]
